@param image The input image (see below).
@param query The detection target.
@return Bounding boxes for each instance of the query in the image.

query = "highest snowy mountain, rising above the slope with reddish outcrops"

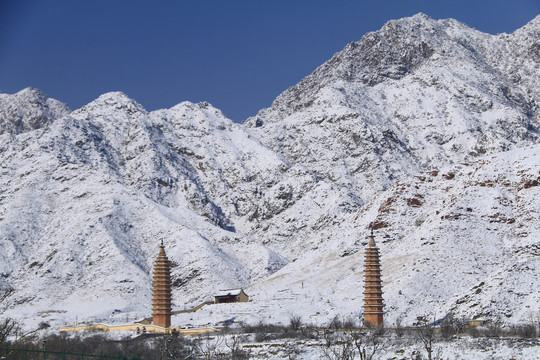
[246,14,540,200]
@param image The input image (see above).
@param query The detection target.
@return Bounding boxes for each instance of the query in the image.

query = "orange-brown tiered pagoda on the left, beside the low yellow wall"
[152,240,172,328]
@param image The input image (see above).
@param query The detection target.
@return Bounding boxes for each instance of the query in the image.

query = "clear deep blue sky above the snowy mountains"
[0,0,540,121]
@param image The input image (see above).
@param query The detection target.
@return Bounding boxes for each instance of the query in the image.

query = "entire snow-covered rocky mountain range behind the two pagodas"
[0,14,540,330]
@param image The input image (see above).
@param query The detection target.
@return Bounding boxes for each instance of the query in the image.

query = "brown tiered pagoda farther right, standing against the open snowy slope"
[364,228,383,327]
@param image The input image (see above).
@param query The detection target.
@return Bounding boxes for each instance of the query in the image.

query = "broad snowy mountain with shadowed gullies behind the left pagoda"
[0,92,354,322]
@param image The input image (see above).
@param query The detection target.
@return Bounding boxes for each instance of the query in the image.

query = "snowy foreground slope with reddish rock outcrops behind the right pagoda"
[248,145,540,325]
